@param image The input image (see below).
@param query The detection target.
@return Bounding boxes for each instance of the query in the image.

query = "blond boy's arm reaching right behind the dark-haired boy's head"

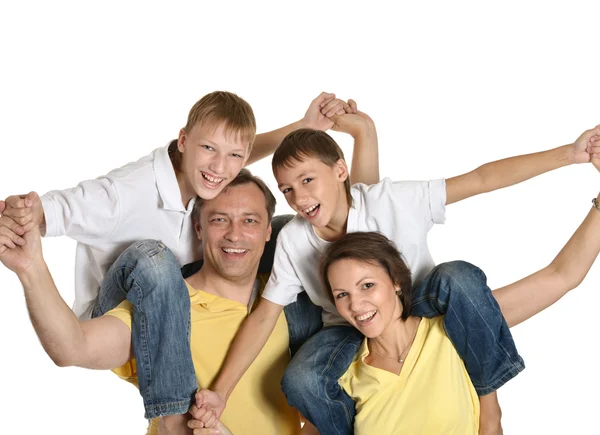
[247,92,352,165]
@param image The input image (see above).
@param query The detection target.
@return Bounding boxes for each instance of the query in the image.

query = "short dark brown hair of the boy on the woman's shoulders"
[271,128,352,206]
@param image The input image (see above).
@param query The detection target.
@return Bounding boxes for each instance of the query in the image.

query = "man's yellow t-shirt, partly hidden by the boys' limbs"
[106,277,300,435]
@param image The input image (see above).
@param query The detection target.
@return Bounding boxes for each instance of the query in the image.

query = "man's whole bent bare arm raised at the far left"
[0,226,131,369]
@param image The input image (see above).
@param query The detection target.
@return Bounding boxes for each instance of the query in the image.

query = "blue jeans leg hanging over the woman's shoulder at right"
[411,261,525,396]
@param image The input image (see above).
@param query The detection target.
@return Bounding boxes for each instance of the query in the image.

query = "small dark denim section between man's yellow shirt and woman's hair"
[283,292,323,358]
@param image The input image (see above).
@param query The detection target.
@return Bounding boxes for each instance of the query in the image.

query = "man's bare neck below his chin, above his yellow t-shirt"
[187,263,258,305]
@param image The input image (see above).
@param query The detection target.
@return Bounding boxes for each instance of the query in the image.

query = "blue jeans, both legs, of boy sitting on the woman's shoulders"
[281,261,525,435]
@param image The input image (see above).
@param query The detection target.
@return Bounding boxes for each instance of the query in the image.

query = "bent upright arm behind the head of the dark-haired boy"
[332,106,379,184]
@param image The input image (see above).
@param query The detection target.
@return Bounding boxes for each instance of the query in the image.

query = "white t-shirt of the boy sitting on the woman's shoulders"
[262,178,446,326]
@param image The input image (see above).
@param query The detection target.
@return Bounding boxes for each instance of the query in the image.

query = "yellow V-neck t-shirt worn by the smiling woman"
[339,317,479,435]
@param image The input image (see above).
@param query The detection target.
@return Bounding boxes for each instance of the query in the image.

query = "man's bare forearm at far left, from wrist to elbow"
[19,261,84,366]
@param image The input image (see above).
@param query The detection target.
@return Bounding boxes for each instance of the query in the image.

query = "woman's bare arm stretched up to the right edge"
[493,186,600,326]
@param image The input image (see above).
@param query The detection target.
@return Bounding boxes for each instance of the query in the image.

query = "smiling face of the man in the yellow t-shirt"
[196,183,271,280]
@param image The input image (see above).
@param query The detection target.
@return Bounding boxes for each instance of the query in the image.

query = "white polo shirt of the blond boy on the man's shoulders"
[42,146,201,319]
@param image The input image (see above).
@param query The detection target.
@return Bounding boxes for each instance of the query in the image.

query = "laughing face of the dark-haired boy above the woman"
[275,157,348,232]
